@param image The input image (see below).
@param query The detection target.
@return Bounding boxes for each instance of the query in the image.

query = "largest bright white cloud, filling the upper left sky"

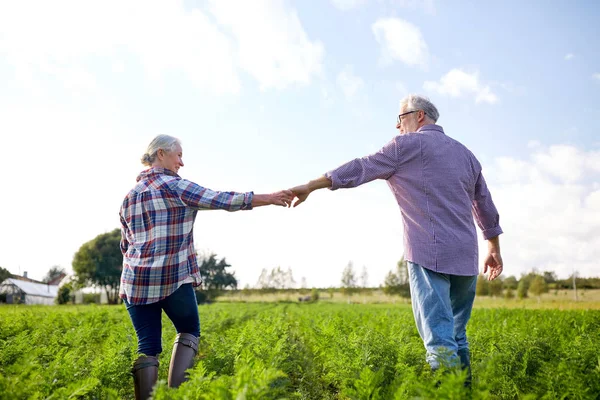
[0,0,324,94]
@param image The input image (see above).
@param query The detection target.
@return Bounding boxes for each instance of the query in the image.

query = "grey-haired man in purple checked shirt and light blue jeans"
[291,95,502,386]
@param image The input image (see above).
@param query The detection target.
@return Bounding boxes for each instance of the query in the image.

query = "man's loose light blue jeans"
[408,261,477,370]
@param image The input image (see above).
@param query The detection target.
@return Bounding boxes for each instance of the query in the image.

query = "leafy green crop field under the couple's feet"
[0,303,600,400]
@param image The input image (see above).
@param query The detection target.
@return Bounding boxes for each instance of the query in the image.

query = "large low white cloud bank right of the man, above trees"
[484,145,600,277]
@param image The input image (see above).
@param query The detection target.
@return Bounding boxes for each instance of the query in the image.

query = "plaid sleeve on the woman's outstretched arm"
[177,179,254,211]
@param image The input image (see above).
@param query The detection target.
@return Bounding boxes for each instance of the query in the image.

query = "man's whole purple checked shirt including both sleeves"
[325,125,502,276]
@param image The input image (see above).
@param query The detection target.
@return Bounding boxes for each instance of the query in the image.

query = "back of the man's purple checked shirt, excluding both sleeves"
[388,125,487,275]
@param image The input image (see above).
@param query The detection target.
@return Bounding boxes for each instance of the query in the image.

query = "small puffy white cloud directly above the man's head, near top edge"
[371,18,429,67]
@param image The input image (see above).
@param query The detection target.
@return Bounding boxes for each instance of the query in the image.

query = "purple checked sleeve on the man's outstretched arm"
[325,139,398,190]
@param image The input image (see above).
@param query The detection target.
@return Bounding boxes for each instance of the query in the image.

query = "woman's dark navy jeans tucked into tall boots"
[124,283,200,357]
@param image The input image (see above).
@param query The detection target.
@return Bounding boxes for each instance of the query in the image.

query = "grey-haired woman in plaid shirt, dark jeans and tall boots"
[119,135,294,399]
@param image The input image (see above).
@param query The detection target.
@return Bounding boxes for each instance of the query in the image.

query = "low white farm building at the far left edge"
[0,278,58,305]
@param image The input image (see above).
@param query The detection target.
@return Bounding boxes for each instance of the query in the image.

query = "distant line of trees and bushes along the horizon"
[0,229,600,304]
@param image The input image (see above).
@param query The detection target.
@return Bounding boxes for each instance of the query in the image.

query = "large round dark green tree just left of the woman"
[73,228,123,304]
